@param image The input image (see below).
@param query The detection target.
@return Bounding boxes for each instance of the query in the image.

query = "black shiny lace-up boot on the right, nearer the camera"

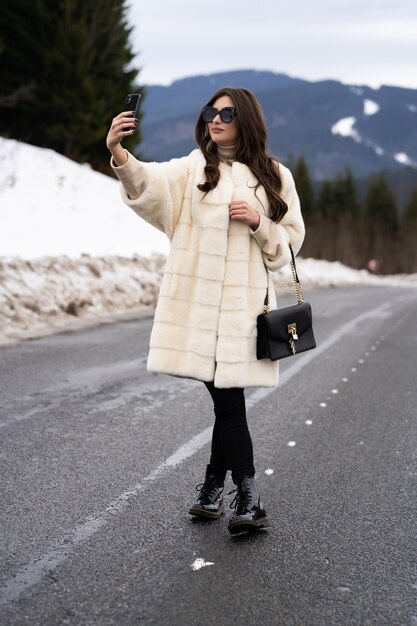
[229,476,269,535]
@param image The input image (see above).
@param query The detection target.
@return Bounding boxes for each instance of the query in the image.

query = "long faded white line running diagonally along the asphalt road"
[0,302,391,607]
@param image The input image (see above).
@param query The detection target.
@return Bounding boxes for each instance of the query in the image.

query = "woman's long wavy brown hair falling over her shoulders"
[195,87,288,222]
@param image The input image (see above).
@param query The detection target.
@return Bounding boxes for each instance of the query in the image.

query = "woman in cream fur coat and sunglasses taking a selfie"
[107,87,304,534]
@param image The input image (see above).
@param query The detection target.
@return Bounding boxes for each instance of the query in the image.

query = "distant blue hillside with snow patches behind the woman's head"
[141,70,417,180]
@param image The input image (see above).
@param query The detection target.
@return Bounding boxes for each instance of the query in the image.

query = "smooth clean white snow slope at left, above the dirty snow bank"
[0,137,169,259]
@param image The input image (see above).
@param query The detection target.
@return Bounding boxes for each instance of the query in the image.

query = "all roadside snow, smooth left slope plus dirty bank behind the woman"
[0,138,417,344]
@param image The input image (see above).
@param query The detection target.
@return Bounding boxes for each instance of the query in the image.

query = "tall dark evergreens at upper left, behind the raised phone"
[0,0,140,170]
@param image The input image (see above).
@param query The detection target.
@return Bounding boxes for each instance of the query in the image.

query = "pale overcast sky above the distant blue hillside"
[129,0,417,88]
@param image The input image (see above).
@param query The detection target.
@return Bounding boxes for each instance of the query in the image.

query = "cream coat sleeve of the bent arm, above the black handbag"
[251,165,305,271]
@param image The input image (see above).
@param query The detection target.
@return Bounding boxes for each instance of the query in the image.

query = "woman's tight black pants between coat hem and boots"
[204,382,255,482]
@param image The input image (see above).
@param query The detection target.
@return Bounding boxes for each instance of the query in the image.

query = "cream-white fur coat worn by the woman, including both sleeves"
[112,150,304,388]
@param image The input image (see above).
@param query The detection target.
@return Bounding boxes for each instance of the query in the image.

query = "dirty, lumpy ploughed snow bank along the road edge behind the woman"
[0,255,417,344]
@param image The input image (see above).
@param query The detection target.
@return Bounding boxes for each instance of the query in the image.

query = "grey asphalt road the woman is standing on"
[0,287,417,626]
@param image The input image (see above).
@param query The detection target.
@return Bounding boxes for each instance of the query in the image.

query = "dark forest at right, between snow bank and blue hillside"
[291,156,417,274]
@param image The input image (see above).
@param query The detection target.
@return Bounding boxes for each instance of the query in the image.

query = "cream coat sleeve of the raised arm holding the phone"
[110,151,190,239]
